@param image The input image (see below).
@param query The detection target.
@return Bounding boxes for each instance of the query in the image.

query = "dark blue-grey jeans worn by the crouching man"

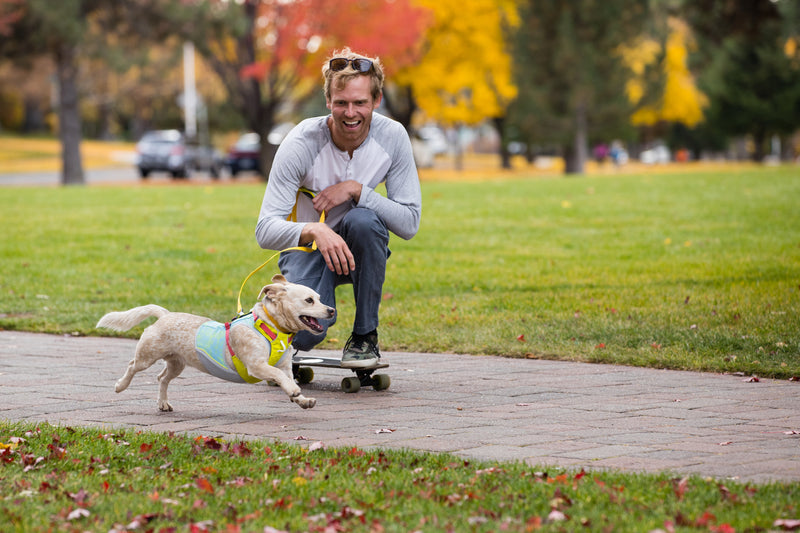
[278,207,391,351]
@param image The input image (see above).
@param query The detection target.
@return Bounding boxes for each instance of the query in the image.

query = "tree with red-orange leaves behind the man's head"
[175,0,428,179]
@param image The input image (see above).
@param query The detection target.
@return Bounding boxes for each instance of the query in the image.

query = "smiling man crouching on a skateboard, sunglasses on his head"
[256,48,422,368]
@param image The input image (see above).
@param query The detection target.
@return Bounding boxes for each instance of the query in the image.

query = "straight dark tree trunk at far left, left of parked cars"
[56,43,85,185]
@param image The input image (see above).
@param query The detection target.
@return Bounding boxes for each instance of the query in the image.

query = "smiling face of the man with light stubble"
[327,76,381,155]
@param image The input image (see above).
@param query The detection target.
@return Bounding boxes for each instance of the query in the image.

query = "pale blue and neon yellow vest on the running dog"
[194,313,293,383]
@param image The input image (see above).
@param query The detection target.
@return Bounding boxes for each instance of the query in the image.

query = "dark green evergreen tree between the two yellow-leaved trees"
[510,0,649,173]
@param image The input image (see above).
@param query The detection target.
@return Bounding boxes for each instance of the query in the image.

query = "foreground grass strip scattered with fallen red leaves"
[0,422,800,533]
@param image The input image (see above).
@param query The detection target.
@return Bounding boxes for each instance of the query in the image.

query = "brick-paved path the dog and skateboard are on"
[0,331,800,482]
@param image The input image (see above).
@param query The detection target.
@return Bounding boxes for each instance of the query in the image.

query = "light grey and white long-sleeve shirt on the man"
[256,113,422,250]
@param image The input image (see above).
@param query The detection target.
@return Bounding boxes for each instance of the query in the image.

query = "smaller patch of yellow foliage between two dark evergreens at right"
[620,17,709,128]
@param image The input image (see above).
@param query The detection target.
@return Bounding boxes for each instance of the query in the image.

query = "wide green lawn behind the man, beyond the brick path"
[0,165,800,378]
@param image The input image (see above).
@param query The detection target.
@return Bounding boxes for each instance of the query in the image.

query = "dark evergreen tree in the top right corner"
[683,0,800,160]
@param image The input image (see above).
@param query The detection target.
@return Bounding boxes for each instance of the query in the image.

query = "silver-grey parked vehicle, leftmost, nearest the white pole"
[136,130,222,178]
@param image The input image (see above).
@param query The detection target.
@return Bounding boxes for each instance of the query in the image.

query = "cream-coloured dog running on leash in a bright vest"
[96,274,336,411]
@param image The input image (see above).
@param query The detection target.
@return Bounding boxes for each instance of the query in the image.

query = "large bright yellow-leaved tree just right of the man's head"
[394,0,519,125]
